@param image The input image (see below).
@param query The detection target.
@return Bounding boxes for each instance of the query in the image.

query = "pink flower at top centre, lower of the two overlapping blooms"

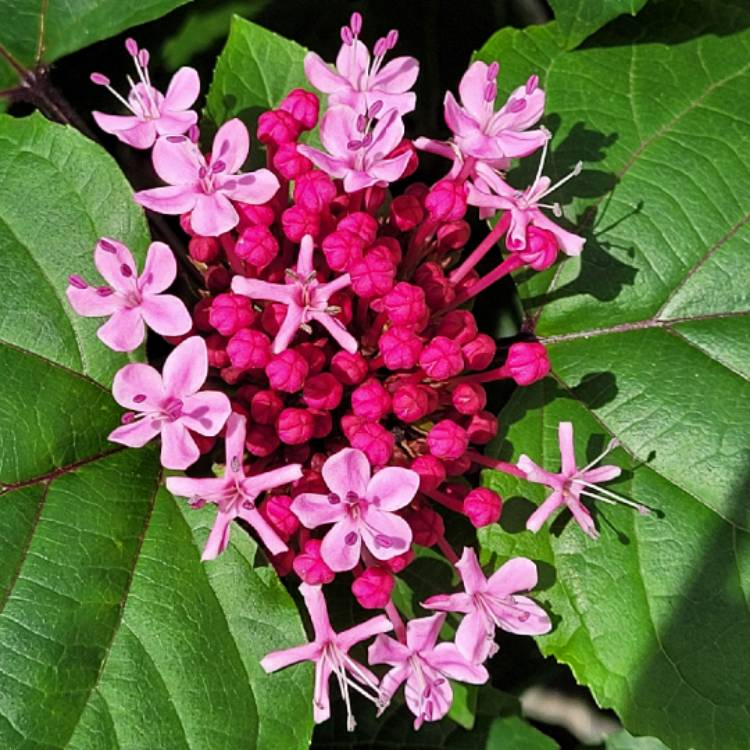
[297,105,410,193]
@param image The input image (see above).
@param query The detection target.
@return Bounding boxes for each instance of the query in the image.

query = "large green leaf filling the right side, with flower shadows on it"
[480,2,750,750]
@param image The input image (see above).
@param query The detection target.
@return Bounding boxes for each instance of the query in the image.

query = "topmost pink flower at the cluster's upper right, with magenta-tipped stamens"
[414,61,549,170]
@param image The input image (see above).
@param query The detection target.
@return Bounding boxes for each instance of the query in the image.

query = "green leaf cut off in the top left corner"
[0,0,189,88]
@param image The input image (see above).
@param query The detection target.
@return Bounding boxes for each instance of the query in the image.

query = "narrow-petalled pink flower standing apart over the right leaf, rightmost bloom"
[518,422,650,539]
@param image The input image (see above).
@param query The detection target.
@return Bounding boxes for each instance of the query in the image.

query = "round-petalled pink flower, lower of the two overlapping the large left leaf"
[109,336,231,469]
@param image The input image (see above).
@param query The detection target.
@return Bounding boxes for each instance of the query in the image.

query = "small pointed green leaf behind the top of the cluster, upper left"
[206,16,310,132]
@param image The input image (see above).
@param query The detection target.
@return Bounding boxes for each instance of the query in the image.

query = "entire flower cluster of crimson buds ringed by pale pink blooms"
[68,19,645,728]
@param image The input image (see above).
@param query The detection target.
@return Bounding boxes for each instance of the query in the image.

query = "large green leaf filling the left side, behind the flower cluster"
[0,115,312,750]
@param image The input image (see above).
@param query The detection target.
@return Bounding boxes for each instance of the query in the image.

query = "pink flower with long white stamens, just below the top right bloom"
[468,144,586,256]
